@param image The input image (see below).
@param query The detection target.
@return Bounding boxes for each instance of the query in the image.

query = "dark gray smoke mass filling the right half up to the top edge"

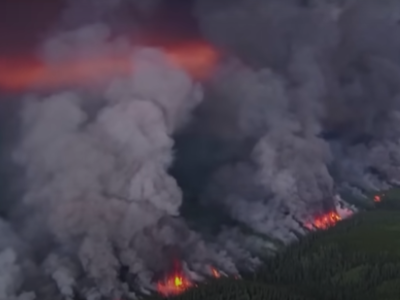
[176,0,400,232]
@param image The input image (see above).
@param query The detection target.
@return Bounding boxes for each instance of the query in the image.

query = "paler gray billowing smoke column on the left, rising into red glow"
[6,26,241,299]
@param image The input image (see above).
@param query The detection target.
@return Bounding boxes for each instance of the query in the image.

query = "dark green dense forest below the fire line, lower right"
[149,190,400,300]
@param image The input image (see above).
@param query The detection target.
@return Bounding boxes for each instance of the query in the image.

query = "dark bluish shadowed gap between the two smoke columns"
[169,103,253,234]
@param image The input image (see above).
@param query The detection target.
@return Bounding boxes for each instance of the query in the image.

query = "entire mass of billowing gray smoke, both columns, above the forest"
[0,0,400,300]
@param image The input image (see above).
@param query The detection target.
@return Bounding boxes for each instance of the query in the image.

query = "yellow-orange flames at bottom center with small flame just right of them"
[157,261,221,297]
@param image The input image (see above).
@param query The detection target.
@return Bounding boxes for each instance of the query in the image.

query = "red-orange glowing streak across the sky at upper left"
[0,41,219,92]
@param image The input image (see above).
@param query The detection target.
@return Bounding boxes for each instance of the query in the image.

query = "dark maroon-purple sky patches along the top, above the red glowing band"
[0,0,199,55]
